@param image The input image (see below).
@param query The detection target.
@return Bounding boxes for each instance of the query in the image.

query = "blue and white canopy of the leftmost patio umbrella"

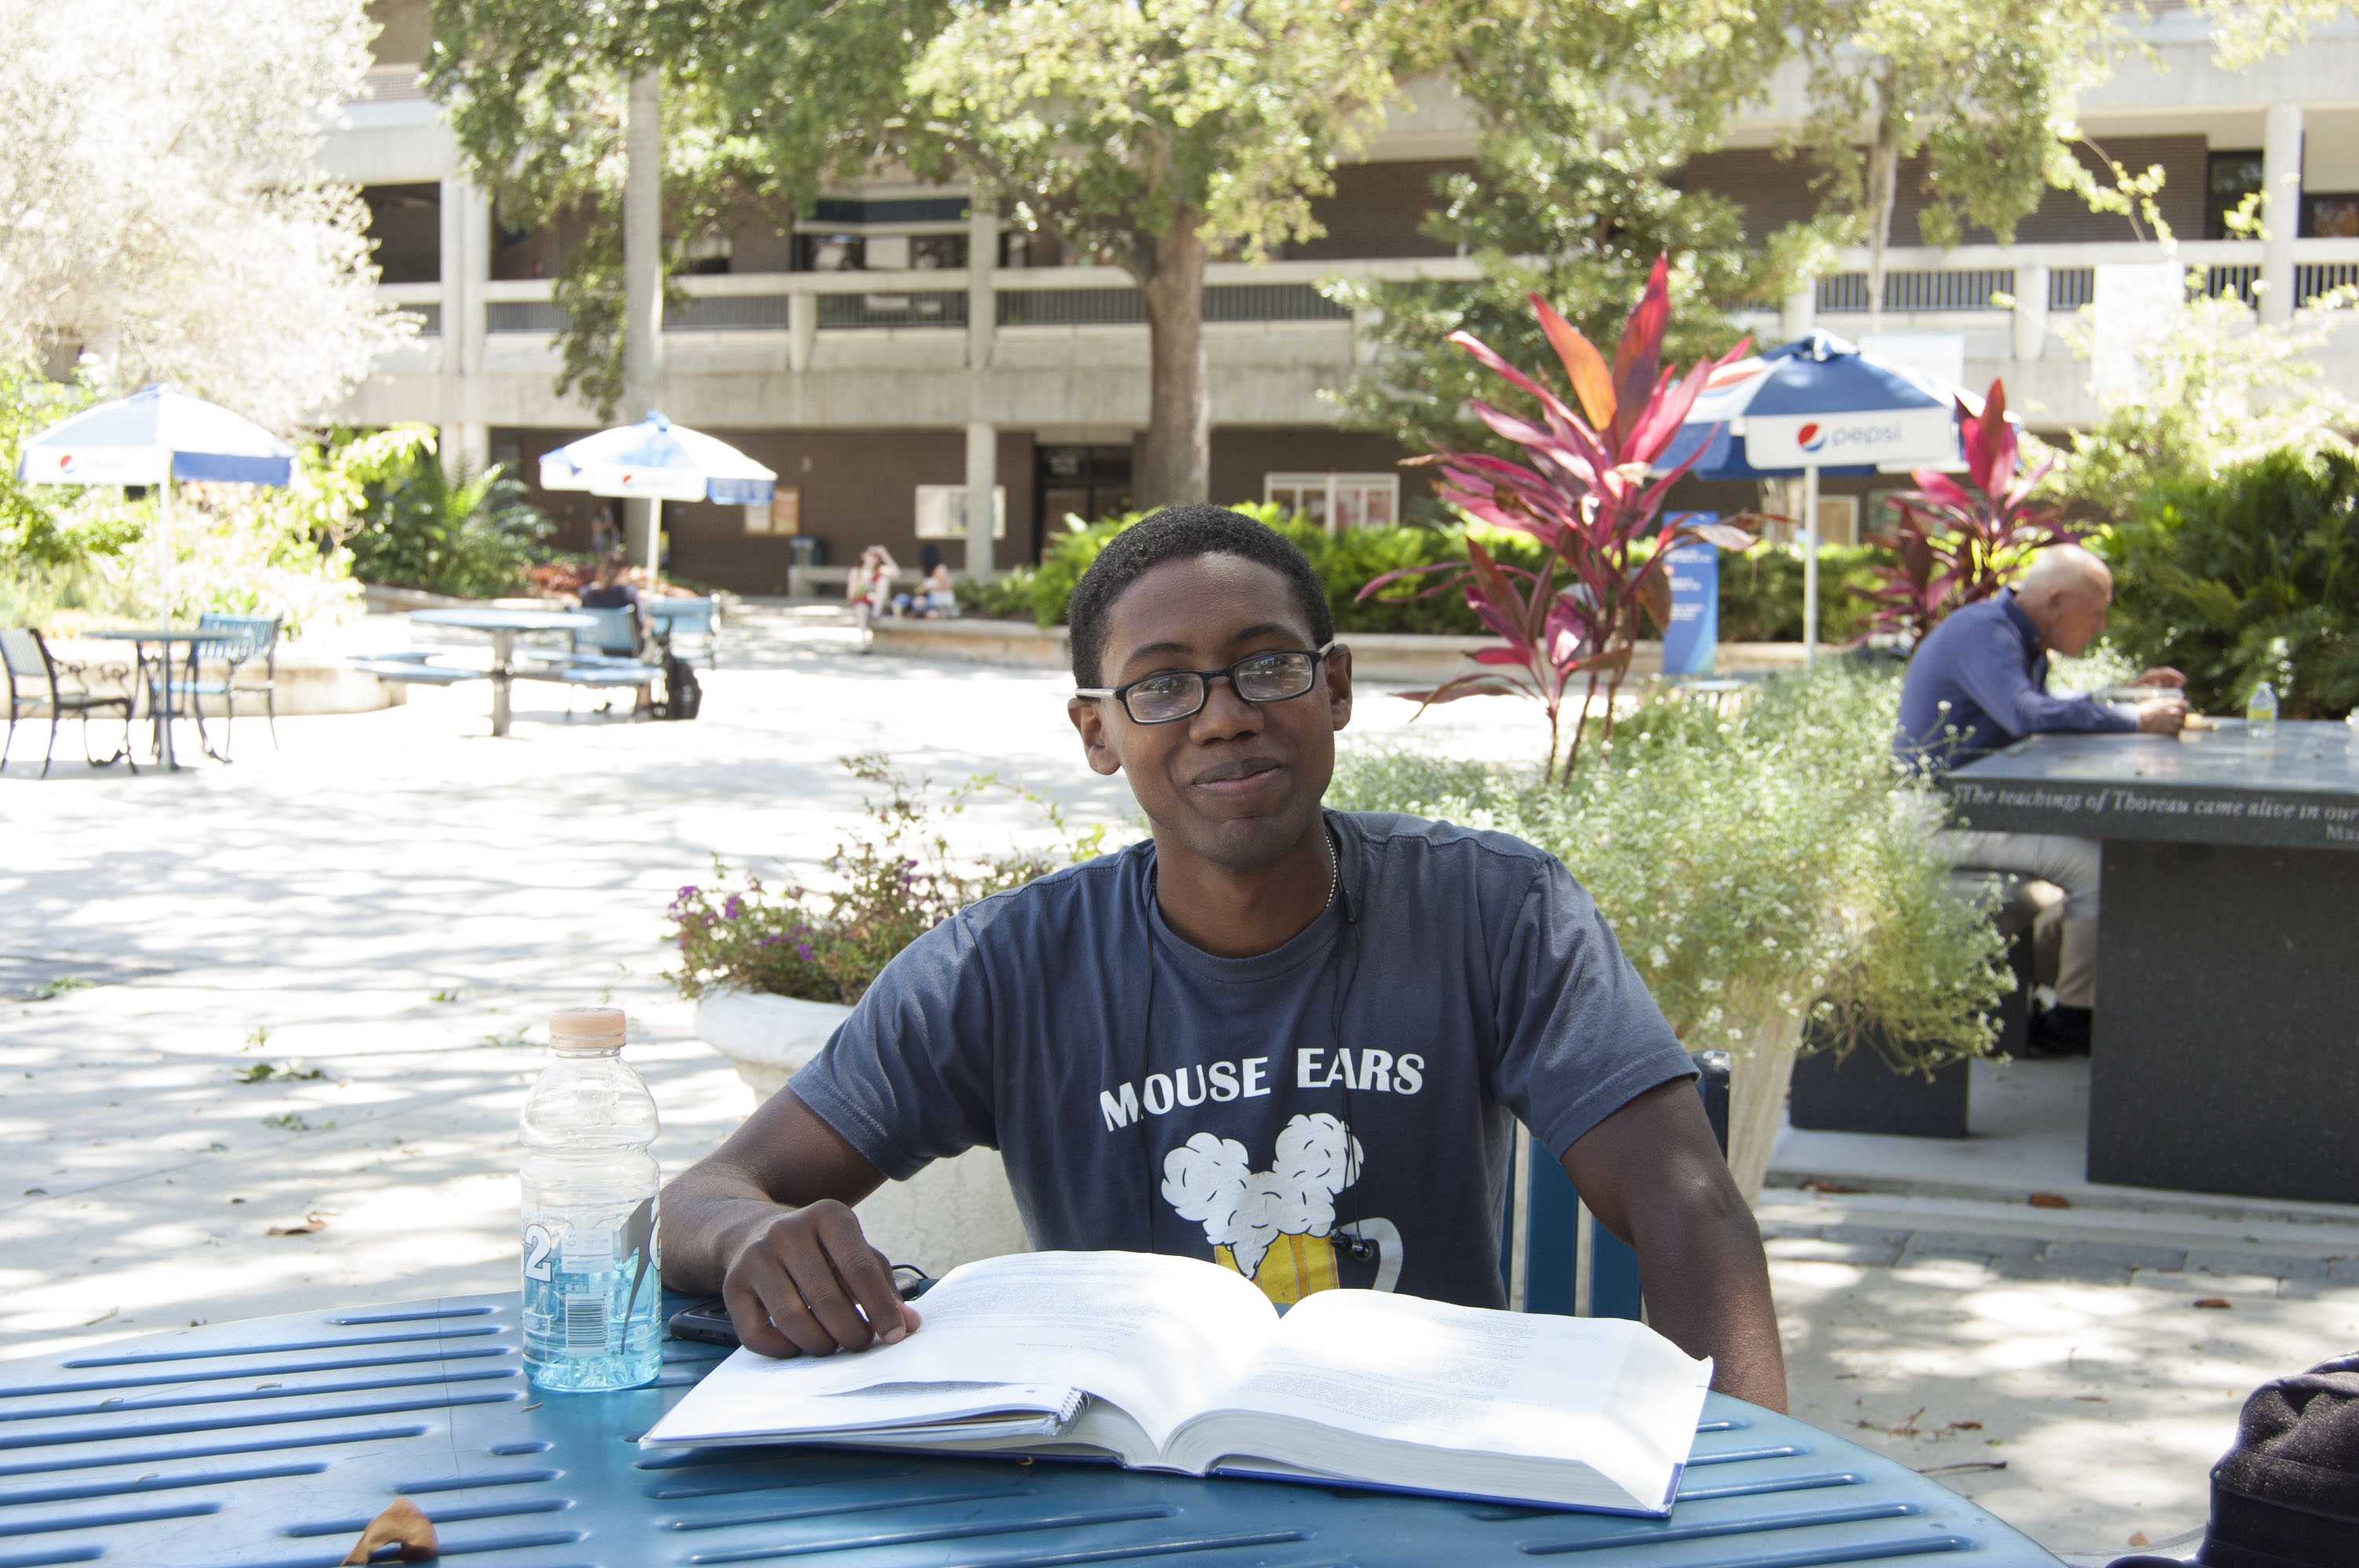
[16,384,295,498]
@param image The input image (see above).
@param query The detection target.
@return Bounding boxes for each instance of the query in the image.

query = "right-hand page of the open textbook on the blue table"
[1175,1290,1710,1509]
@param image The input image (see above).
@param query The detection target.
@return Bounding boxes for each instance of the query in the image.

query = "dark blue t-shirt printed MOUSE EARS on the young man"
[793,811,1694,1306]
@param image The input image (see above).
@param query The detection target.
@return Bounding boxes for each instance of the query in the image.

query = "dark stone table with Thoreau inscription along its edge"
[1944,719,2359,1203]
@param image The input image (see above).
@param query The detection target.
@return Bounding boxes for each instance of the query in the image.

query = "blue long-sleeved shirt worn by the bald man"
[1892,587,2137,773]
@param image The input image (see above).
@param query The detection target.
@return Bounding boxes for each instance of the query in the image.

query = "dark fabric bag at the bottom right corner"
[2114,1356,2359,1568]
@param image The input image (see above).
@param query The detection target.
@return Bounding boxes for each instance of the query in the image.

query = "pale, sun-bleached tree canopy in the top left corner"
[0,0,398,429]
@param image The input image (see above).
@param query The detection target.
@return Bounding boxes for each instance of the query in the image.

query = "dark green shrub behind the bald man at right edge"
[2099,450,2359,719]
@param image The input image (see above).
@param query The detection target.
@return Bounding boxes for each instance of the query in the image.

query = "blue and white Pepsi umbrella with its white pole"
[1656,332,1982,660]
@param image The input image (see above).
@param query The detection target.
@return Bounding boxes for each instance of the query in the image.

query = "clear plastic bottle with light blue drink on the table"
[522,1007,663,1391]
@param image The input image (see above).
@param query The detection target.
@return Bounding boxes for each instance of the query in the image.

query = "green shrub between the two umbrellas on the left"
[347,448,554,599]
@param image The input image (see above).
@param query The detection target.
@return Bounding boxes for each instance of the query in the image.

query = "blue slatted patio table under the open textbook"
[0,1294,2059,1568]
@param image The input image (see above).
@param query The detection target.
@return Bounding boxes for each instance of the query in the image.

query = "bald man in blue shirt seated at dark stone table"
[1892,545,2186,1054]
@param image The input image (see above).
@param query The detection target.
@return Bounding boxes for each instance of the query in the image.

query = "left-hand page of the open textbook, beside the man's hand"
[646,1252,1276,1448]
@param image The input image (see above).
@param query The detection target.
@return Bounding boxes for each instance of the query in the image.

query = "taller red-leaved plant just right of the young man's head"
[1359,257,1753,780]
